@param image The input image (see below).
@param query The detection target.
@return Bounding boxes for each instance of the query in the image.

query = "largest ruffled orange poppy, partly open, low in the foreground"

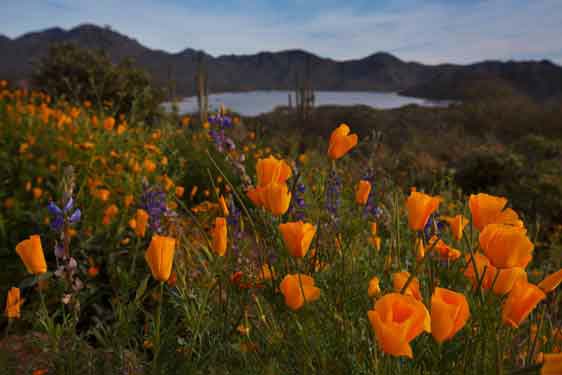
[368,293,431,358]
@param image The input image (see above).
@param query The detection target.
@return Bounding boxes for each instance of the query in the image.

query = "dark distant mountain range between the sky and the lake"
[0,24,562,99]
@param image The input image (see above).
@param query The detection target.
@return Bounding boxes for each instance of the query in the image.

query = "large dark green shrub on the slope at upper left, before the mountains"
[32,44,163,120]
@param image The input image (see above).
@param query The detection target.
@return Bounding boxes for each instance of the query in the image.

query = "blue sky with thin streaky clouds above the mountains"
[0,0,562,64]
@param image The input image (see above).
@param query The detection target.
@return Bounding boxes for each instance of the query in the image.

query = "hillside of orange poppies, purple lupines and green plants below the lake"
[0,54,562,374]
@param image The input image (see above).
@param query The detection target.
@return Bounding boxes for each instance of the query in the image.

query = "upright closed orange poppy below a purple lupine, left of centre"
[144,235,176,282]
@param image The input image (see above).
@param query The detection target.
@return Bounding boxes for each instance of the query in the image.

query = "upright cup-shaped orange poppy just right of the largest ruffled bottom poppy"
[431,288,470,344]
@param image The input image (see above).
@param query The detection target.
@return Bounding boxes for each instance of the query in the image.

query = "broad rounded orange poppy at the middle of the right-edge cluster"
[479,224,534,268]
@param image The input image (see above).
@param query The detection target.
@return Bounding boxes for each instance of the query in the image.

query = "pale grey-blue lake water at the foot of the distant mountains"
[165,91,449,116]
